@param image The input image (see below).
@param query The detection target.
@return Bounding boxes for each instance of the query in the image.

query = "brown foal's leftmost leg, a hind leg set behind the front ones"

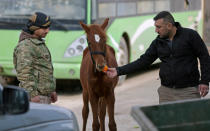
[82,89,89,131]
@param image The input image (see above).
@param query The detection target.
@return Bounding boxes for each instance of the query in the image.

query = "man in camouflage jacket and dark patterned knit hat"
[13,12,57,104]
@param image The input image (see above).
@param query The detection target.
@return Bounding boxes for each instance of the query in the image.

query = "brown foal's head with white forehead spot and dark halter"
[80,18,109,71]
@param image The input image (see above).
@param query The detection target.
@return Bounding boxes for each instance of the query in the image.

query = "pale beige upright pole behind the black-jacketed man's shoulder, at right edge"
[202,0,210,49]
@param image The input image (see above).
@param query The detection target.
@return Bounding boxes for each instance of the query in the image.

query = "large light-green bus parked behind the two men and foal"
[0,0,202,88]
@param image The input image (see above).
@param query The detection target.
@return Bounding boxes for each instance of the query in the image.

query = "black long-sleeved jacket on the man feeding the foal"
[116,22,210,88]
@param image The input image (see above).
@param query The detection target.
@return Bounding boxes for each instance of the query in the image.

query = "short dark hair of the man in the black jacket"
[153,11,175,25]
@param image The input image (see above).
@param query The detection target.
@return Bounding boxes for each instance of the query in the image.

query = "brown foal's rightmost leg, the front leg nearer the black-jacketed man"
[107,90,117,131]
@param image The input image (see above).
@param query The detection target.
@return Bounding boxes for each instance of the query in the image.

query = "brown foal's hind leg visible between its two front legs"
[98,97,106,131]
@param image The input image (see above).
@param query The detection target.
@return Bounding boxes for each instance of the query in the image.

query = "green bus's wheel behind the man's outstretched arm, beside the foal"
[117,37,128,85]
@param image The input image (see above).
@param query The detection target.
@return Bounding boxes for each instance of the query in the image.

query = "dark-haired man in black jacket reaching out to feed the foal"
[106,11,210,103]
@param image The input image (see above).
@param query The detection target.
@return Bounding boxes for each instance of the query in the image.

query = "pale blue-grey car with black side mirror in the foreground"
[0,86,79,131]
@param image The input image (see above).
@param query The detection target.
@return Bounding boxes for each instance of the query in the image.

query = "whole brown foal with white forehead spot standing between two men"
[80,18,118,131]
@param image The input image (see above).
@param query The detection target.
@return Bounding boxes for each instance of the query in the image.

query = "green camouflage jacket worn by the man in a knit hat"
[13,32,56,97]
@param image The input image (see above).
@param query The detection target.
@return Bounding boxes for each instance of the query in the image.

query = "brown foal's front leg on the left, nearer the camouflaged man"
[90,94,100,131]
